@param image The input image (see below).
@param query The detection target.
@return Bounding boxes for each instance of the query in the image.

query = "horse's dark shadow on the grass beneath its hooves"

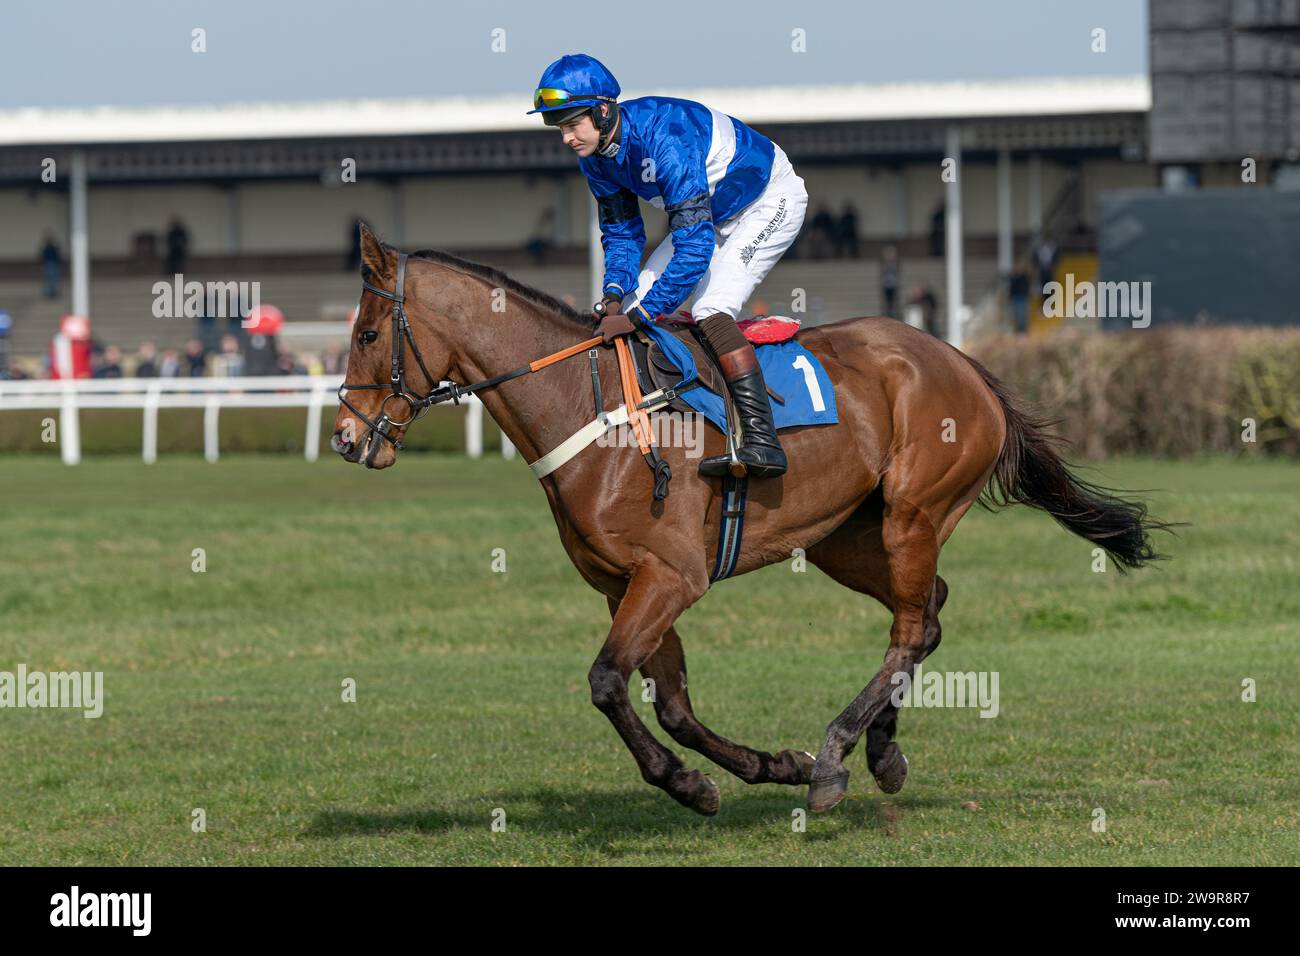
[303,787,952,852]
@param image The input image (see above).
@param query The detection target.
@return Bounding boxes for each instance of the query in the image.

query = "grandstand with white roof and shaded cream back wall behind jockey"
[0,77,1159,364]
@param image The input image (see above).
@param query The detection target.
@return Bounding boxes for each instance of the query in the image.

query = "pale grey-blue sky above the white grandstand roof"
[0,0,1148,109]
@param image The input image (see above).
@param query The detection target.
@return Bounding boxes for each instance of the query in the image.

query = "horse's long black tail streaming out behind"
[965,355,1171,571]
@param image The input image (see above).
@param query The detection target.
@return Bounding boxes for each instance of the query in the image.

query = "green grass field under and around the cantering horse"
[0,454,1300,865]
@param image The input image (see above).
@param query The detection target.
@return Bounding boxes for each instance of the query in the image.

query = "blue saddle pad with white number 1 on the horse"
[647,324,840,431]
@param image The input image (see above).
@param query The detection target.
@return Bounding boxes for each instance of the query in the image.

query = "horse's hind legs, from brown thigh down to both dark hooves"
[809,501,946,812]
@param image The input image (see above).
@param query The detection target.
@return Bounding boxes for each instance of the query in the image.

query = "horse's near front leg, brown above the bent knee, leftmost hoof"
[588,555,722,816]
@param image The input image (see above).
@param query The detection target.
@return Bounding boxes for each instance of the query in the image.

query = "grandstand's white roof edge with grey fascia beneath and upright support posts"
[0,77,1151,346]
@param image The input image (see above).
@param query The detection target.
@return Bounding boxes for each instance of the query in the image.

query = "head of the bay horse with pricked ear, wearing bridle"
[330,222,451,468]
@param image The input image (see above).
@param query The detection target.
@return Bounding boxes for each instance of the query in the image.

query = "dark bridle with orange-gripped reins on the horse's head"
[338,252,602,464]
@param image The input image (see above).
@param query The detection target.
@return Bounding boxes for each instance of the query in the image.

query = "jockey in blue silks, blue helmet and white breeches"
[529,53,807,477]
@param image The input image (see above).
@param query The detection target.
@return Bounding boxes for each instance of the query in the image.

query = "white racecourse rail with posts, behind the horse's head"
[0,375,515,464]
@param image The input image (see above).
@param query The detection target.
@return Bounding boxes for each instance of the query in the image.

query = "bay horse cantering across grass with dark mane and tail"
[330,224,1167,816]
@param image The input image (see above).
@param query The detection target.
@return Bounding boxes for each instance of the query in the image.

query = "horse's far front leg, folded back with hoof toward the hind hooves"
[610,598,814,784]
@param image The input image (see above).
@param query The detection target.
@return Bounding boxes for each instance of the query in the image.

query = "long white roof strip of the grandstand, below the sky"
[0,75,1151,146]
